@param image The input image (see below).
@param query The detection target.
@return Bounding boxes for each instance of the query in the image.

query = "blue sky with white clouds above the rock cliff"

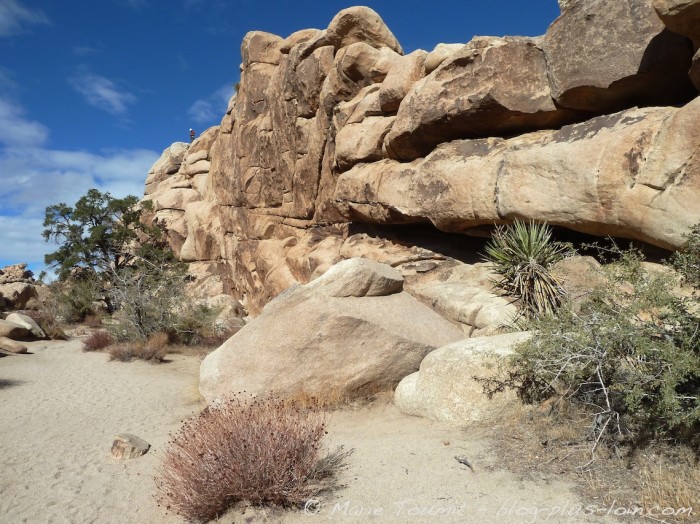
[0,0,559,273]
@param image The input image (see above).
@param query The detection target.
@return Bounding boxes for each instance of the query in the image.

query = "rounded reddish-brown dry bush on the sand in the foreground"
[156,398,347,521]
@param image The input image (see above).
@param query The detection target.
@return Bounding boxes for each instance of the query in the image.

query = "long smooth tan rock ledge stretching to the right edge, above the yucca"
[334,98,700,248]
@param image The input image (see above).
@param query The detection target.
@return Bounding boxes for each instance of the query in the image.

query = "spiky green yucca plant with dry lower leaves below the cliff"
[484,220,572,318]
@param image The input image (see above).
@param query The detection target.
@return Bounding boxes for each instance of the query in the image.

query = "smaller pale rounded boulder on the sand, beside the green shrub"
[394,332,530,425]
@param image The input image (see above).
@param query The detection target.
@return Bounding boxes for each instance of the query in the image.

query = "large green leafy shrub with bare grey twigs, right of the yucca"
[511,245,700,451]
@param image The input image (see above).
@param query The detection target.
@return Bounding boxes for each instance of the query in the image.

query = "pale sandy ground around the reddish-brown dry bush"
[0,340,613,524]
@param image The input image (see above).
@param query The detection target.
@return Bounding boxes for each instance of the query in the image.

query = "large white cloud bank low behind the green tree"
[0,97,160,271]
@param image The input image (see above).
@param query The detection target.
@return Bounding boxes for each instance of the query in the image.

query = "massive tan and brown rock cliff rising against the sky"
[145,0,700,320]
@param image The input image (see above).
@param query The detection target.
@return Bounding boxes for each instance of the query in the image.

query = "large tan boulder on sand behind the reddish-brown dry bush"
[200,259,463,401]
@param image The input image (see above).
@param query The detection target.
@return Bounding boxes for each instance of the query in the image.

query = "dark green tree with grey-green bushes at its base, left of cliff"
[44,189,231,362]
